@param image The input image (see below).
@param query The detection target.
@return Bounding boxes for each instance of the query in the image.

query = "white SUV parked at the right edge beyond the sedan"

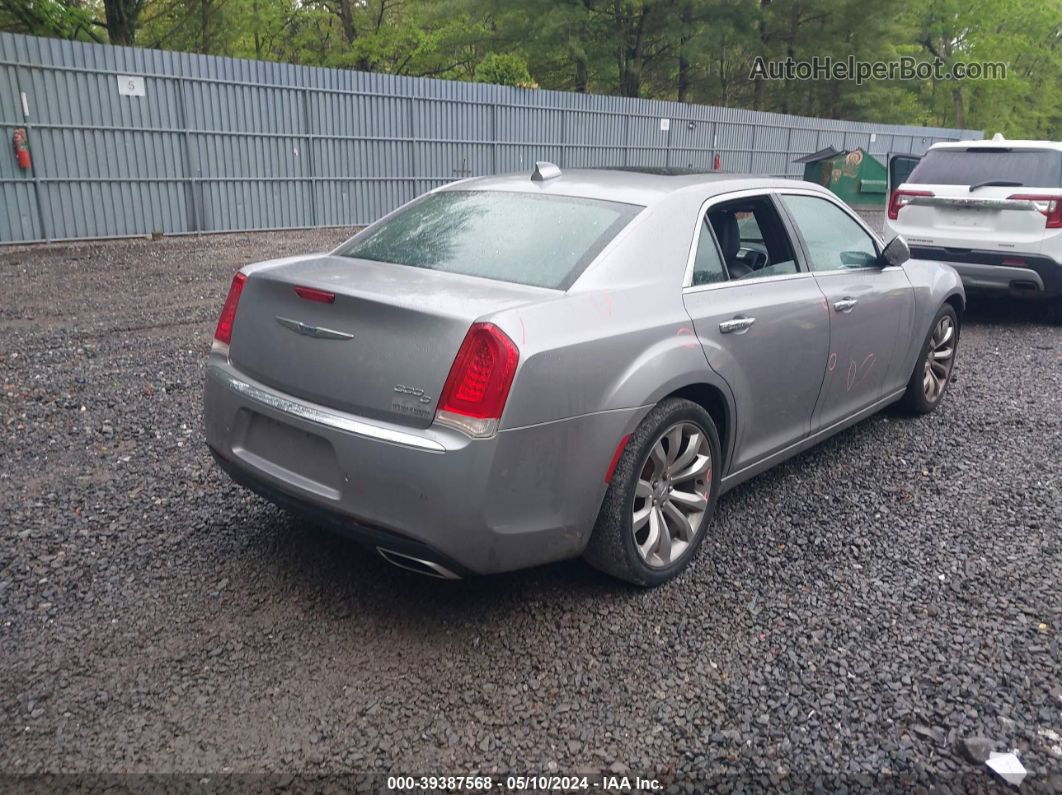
[885,135,1062,296]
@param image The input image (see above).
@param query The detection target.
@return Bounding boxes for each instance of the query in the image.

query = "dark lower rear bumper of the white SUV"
[911,246,1062,295]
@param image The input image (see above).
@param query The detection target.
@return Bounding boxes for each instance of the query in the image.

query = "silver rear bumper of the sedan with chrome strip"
[204,355,644,574]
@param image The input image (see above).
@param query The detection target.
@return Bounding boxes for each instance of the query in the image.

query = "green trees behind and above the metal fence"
[0,0,1062,139]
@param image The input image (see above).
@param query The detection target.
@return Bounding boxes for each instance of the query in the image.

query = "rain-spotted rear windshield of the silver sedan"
[338,190,643,290]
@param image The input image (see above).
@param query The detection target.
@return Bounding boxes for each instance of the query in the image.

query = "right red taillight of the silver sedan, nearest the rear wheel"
[435,323,520,437]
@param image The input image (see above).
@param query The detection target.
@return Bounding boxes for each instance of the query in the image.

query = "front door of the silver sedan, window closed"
[782,190,914,431]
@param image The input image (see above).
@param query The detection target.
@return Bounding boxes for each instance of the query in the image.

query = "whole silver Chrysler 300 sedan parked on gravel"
[205,163,964,585]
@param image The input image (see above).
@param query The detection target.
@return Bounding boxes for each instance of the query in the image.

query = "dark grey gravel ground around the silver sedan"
[0,230,1062,791]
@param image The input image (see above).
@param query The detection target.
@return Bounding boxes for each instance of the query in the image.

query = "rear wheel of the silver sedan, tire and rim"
[583,398,722,587]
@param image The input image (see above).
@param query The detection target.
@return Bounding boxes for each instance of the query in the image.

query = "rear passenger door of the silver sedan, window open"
[683,191,829,473]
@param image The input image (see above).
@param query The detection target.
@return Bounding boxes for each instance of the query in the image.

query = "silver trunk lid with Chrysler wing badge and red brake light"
[229,256,560,428]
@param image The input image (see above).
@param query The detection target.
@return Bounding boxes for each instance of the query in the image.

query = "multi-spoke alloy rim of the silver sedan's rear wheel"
[631,422,712,568]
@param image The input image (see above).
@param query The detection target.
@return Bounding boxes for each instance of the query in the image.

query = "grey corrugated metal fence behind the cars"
[0,34,980,243]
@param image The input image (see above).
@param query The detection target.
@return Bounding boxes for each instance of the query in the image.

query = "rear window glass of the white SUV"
[907,146,1062,188]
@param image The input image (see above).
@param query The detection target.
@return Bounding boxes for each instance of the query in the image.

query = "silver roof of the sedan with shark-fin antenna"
[441,168,811,206]
